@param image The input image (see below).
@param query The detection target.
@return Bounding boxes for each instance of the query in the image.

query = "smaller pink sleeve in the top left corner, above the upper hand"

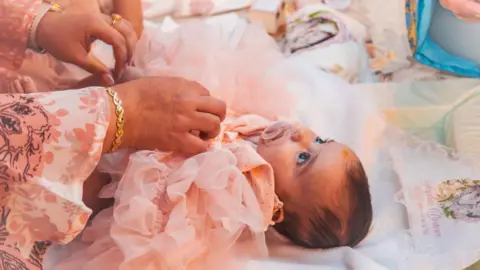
[0,0,42,84]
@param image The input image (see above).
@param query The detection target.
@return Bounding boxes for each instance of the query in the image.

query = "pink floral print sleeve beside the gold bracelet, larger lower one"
[0,88,111,270]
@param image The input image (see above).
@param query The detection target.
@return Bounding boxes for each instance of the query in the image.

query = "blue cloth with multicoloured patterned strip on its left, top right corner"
[405,0,480,78]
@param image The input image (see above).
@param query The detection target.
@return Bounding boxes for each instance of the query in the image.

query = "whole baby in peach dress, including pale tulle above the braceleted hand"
[42,20,372,270]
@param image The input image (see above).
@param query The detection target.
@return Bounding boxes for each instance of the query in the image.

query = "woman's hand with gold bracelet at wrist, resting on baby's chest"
[104,77,226,155]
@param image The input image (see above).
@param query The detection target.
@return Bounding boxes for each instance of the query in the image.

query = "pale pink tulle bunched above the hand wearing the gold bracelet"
[134,21,295,119]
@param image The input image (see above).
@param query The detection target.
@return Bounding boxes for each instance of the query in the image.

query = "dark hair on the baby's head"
[275,161,373,249]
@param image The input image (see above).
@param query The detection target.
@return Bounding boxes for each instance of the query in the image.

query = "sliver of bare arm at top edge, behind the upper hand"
[113,0,143,37]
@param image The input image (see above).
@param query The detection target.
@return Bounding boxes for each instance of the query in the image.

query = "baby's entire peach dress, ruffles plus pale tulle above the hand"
[56,22,293,270]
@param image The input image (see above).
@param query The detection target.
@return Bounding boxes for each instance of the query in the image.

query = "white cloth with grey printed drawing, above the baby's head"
[283,4,373,83]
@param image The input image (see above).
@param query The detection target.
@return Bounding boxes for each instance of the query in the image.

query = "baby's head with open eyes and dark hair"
[258,122,373,248]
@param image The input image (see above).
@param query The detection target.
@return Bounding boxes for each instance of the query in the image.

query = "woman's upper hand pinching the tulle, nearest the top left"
[36,5,137,85]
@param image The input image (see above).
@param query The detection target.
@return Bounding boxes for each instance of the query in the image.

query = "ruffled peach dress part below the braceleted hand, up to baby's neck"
[55,115,281,270]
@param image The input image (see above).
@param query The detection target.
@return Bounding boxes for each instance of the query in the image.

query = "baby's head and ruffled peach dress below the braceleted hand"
[56,109,372,270]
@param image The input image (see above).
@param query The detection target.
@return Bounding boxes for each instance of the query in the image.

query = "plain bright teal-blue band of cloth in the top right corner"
[414,0,480,78]
